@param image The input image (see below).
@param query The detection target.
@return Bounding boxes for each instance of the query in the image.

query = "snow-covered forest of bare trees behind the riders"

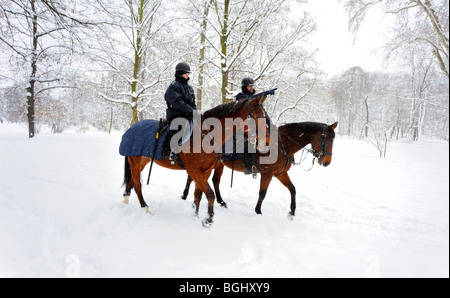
[0,0,449,144]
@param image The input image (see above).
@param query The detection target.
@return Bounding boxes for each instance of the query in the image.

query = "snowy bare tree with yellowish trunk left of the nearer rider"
[97,0,175,125]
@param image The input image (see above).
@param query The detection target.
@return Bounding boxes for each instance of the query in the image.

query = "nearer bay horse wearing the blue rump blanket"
[123,95,267,227]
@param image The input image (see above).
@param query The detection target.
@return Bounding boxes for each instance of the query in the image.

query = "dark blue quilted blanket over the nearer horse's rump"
[119,120,169,160]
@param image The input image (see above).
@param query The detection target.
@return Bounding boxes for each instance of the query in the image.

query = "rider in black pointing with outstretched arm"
[236,77,277,178]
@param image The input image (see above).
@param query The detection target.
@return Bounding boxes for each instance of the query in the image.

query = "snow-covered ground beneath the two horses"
[0,124,449,278]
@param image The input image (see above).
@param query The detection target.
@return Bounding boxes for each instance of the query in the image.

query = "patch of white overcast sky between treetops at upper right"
[308,0,387,75]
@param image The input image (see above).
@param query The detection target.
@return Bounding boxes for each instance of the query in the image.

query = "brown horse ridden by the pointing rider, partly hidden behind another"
[182,122,338,219]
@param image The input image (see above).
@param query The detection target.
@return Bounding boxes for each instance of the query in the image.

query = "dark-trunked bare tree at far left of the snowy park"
[0,0,100,138]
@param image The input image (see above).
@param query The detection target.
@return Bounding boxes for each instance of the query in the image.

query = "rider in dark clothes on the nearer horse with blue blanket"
[163,62,197,158]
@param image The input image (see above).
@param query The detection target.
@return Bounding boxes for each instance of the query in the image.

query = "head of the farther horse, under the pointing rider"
[311,122,338,167]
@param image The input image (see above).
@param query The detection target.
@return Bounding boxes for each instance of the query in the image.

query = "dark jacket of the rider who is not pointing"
[164,76,197,120]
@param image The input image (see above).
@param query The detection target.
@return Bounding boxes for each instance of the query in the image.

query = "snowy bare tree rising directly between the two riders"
[195,0,315,102]
